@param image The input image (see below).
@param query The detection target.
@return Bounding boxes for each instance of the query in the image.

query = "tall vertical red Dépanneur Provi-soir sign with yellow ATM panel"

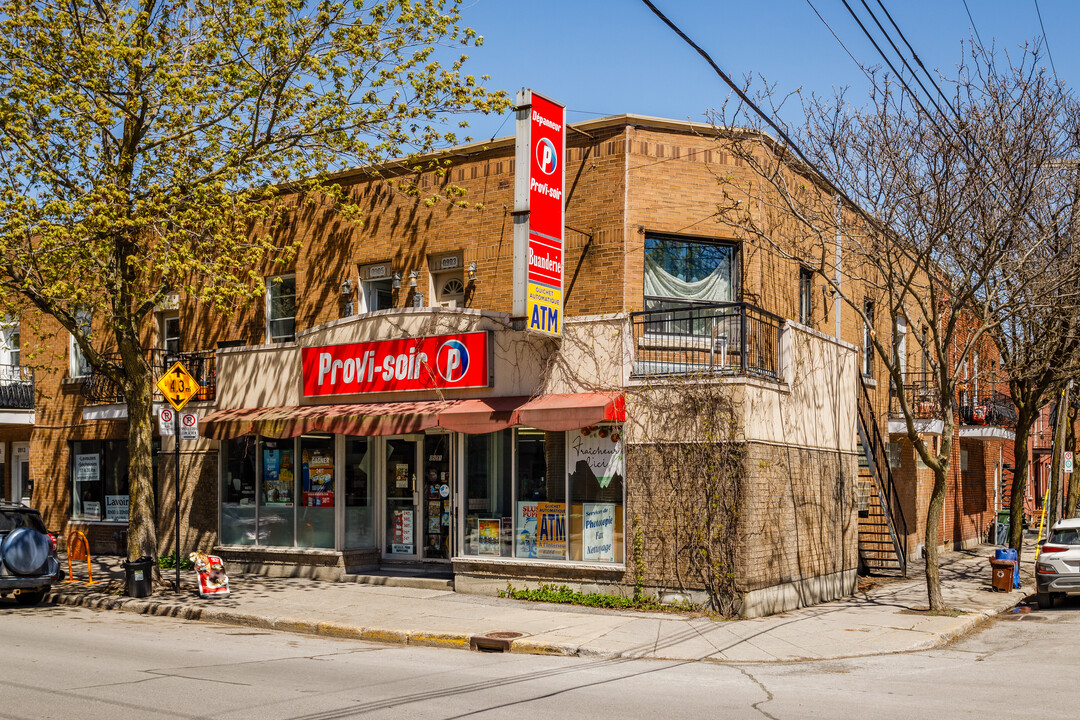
[513,90,566,337]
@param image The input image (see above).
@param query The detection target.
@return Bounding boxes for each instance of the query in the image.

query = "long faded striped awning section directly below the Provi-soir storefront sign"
[200,400,447,440]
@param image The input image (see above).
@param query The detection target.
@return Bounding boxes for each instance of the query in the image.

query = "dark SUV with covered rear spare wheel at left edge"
[0,503,64,604]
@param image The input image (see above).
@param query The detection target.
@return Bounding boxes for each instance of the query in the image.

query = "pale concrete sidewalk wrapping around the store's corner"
[50,545,1034,663]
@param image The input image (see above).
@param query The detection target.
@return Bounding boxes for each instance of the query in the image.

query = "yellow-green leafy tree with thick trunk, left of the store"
[0,0,509,558]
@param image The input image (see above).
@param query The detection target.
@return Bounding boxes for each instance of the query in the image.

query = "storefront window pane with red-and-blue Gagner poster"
[296,435,335,547]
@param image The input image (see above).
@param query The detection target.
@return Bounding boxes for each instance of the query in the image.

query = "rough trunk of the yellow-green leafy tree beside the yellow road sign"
[117,331,158,560]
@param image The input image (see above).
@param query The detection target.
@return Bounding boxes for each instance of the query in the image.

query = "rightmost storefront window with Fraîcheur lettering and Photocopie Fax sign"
[566,425,625,562]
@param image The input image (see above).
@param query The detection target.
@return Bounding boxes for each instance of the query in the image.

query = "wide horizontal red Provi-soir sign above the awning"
[300,330,491,397]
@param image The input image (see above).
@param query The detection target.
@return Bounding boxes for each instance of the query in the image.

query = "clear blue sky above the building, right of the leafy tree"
[455,0,1080,139]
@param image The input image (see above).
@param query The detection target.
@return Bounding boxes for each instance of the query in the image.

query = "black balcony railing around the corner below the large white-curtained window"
[630,302,783,380]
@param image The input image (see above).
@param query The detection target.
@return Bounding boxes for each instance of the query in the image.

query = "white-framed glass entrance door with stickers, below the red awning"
[382,438,421,560]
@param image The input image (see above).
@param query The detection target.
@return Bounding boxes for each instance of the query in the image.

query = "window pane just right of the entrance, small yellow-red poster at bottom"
[464,430,514,557]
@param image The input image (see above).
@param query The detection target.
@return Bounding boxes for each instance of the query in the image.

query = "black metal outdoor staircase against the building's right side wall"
[858,373,907,575]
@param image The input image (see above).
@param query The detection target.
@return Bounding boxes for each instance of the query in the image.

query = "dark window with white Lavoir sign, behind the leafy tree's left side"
[70,440,129,522]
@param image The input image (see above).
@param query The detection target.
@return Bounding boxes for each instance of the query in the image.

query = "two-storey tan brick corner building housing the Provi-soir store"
[0,110,1008,614]
